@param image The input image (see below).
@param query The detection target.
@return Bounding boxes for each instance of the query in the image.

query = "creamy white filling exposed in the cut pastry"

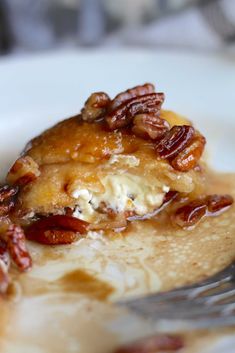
[71,155,169,222]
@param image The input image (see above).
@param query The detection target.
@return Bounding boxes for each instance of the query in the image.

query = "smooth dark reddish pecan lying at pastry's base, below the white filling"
[26,215,89,245]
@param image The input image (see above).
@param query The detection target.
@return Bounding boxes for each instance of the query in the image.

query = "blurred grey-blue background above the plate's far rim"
[0,0,235,55]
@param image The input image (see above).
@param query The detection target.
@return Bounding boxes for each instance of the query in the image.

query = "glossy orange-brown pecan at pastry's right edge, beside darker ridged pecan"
[170,133,206,172]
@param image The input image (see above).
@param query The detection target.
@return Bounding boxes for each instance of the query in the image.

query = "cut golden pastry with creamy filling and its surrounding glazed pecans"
[0,83,233,293]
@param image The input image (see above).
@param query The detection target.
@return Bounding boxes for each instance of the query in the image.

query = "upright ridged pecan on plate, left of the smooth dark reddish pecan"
[6,224,32,271]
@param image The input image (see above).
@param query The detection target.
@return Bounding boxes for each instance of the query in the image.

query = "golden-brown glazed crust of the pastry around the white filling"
[7,111,204,216]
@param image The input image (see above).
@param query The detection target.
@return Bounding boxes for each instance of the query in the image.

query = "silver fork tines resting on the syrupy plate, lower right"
[118,262,235,329]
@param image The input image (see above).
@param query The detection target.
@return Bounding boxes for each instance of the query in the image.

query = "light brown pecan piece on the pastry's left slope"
[7,156,40,186]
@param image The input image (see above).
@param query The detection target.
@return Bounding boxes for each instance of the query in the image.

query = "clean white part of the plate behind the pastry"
[0,51,235,353]
